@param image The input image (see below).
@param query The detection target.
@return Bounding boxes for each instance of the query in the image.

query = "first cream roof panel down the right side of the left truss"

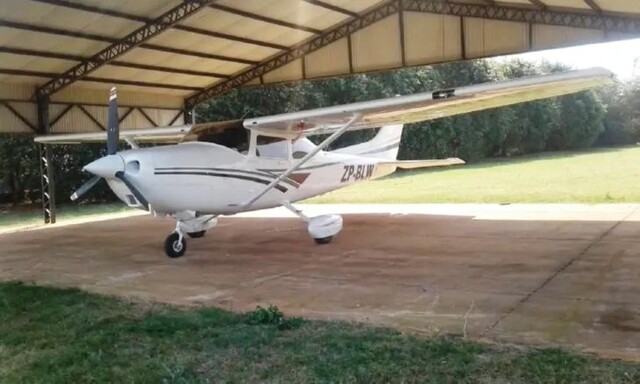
[183,9,313,46]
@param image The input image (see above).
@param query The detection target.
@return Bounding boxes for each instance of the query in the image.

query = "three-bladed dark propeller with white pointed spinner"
[71,87,149,210]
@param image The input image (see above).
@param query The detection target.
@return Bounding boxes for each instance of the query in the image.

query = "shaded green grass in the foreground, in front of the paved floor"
[0,283,640,384]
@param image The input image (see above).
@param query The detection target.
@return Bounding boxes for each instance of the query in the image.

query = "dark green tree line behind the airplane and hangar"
[0,60,640,206]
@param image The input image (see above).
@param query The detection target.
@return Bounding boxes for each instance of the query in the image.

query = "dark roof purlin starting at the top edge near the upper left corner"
[31,0,288,50]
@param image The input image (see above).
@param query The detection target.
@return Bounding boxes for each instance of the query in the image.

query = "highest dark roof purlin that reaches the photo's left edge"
[0,20,252,64]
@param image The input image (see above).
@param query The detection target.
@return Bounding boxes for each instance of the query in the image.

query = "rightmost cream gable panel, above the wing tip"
[533,24,604,49]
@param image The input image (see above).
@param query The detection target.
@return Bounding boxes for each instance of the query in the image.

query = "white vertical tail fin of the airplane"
[332,124,403,160]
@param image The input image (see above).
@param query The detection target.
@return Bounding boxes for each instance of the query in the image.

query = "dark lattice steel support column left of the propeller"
[37,96,56,224]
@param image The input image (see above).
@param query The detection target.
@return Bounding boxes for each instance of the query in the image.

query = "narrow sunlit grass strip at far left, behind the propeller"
[0,202,131,229]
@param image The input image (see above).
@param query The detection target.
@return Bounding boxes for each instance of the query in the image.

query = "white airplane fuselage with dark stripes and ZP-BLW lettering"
[107,142,395,215]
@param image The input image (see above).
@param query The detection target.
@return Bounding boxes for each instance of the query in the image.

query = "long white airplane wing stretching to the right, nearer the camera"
[243,68,615,137]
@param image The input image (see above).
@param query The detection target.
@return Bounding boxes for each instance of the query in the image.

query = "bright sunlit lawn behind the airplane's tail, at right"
[308,147,640,203]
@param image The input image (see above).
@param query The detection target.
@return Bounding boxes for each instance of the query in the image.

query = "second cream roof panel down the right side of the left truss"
[150,29,279,61]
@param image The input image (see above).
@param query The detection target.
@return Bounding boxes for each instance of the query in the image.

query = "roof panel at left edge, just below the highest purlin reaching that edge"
[0,27,108,56]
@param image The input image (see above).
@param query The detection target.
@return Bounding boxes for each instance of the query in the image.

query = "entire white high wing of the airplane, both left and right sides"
[35,68,615,144]
